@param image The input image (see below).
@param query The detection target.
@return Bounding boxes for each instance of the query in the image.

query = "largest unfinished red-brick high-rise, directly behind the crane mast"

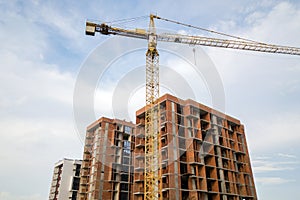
[132,94,257,200]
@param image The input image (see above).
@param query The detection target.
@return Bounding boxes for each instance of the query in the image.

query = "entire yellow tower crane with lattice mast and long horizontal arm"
[86,14,300,200]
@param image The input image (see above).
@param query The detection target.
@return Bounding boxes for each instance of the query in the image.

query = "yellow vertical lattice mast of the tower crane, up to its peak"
[144,15,162,200]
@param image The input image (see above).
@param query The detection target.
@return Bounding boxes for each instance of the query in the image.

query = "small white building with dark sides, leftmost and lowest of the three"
[49,158,81,200]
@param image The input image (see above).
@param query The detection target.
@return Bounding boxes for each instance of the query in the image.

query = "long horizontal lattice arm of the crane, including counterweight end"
[86,22,300,55]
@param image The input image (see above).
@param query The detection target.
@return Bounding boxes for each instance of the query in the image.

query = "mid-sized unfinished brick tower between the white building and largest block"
[78,117,135,200]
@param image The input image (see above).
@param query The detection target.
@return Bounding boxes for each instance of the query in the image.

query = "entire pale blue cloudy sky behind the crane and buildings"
[0,0,300,200]
